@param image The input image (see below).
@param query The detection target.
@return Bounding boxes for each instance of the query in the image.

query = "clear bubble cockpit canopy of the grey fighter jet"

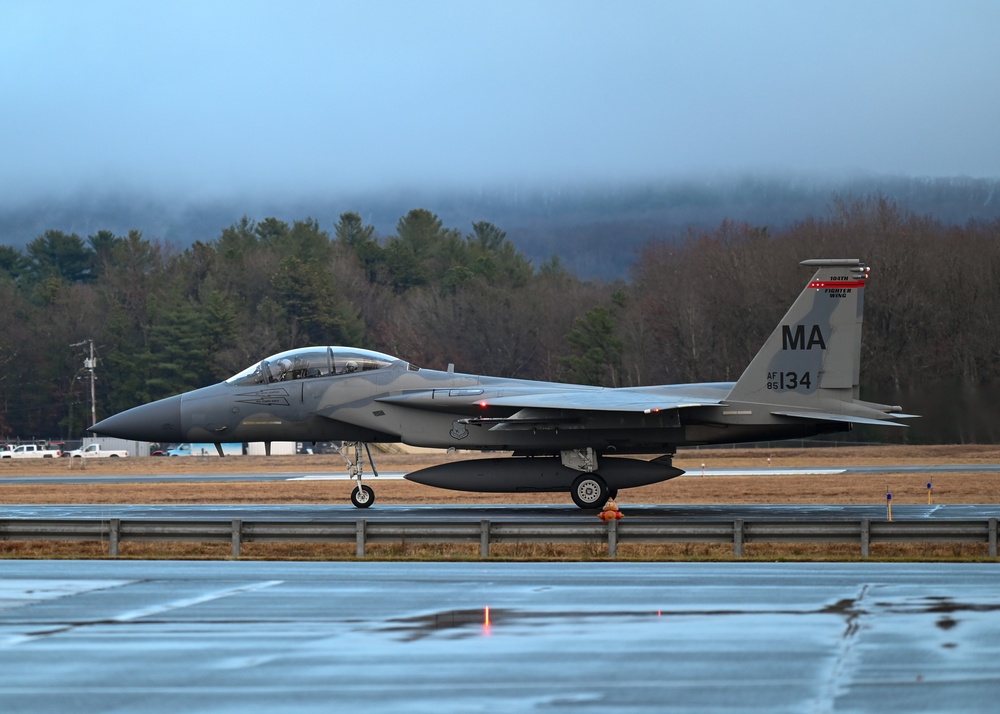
[226,347,402,385]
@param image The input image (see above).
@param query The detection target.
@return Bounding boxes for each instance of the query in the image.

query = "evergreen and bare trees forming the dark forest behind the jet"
[0,195,1000,442]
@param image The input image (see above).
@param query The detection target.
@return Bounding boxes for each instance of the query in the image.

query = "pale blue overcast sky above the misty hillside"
[0,0,1000,201]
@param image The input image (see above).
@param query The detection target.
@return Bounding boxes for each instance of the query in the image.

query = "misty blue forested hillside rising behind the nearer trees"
[0,176,1000,280]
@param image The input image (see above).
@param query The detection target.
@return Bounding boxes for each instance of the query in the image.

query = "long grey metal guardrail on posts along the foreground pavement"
[0,518,997,558]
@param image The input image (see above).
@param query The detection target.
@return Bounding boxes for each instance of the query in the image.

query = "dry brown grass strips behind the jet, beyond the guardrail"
[0,446,1000,508]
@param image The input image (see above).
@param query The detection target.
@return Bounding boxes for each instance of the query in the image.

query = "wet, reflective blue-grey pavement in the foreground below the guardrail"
[0,561,1000,714]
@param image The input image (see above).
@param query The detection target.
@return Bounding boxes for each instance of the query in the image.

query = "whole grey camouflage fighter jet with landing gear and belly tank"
[90,259,913,508]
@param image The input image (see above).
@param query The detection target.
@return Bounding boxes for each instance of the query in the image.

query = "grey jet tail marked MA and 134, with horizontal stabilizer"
[726,259,900,423]
